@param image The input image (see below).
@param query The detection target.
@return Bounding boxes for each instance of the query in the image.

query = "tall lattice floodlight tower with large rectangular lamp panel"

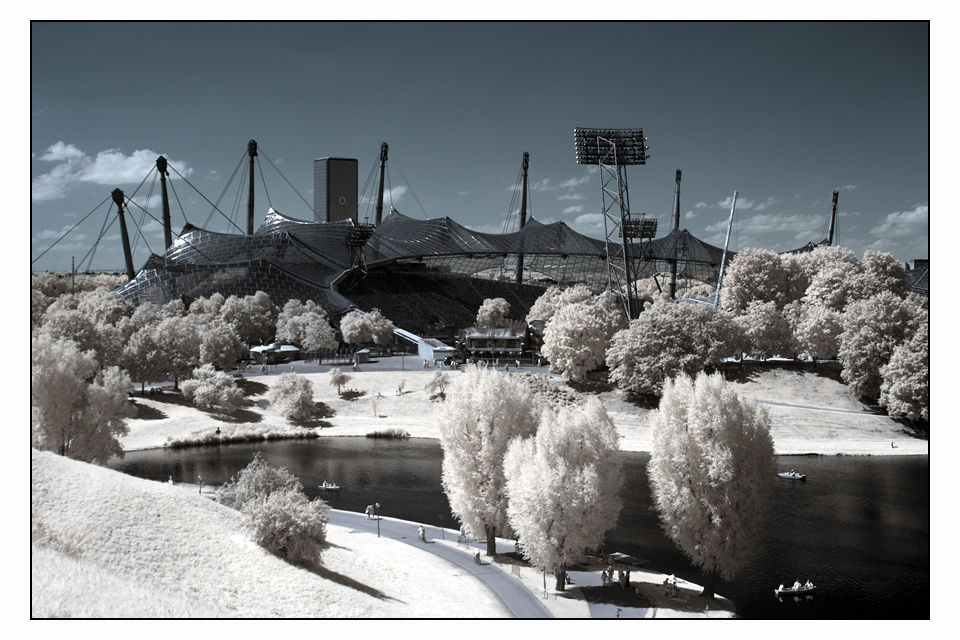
[574,127,656,321]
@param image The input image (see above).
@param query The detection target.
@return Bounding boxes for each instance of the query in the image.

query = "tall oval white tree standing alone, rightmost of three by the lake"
[648,373,776,598]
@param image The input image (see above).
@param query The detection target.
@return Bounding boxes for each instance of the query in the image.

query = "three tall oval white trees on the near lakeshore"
[438,367,775,597]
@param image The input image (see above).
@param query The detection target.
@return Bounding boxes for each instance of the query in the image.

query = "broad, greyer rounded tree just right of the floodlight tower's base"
[607,298,741,395]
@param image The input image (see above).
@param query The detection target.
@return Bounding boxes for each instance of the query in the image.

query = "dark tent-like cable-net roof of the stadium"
[118,209,824,314]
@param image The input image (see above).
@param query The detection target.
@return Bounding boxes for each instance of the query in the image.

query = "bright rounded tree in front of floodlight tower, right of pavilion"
[541,290,627,380]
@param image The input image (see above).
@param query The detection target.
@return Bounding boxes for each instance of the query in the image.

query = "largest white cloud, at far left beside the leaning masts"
[30,142,193,202]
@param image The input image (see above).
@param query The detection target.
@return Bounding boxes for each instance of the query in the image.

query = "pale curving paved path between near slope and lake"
[327,509,553,618]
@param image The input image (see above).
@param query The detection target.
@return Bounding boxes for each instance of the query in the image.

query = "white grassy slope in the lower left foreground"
[31,451,506,618]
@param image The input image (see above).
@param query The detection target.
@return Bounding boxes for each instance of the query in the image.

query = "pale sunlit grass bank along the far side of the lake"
[114,357,930,456]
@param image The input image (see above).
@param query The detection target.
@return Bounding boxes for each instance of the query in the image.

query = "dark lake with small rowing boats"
[108,437,930,619]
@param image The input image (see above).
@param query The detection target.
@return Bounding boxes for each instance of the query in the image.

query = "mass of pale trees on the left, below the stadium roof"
[31,276,402,463]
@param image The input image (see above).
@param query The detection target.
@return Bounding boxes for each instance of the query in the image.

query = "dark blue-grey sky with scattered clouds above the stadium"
[29,21,931,271]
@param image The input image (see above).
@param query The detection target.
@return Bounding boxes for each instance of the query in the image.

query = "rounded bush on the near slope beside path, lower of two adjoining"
[241,489,330,564]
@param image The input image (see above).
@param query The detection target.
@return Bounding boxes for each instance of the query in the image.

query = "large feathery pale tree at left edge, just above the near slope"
[30,335,135,464]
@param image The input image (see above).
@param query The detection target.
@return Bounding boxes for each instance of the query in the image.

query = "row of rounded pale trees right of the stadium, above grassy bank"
[527,247,929,421]
